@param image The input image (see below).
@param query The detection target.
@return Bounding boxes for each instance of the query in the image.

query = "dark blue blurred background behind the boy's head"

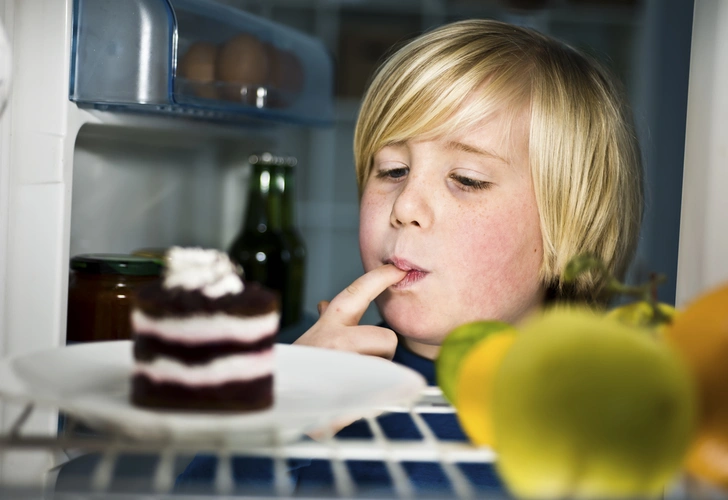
[225,0,693,324]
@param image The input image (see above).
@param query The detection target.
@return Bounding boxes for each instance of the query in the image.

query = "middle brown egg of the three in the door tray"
[220,33,268,102]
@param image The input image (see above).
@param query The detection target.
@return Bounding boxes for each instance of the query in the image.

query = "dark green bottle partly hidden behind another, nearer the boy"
[276,156,306,326]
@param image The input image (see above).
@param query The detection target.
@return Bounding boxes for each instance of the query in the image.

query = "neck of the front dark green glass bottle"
[245,165,281,233]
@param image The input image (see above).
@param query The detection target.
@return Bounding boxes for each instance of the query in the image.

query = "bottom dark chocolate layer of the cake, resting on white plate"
[131,375,273,411]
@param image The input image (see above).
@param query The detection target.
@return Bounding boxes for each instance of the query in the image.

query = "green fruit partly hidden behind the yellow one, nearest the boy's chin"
[435,321,512,405]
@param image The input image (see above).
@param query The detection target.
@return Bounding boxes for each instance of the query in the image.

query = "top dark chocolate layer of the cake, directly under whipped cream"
[136,281,279,318]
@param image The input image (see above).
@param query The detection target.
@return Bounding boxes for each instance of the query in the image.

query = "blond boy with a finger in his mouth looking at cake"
[180,20,642,491]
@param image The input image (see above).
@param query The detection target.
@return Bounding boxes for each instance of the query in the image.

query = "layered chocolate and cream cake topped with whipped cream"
[131,247,280,411]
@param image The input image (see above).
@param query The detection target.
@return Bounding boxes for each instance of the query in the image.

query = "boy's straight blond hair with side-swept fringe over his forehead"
[354,20,643,303]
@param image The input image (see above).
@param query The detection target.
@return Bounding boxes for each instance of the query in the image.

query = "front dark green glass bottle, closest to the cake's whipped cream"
[228,153,288,320]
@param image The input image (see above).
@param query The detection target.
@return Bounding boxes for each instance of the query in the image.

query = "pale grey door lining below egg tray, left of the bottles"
[69,125,276,256]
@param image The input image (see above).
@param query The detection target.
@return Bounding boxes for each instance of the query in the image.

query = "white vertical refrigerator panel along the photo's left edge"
[0,0,82,362]
